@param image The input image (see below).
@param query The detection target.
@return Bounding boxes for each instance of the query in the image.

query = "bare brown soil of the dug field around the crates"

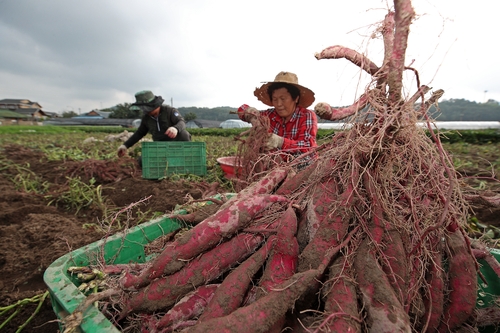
[0,141,500,333]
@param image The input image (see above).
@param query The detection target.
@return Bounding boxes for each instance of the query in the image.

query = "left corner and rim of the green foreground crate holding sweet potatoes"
[43,217,181,333]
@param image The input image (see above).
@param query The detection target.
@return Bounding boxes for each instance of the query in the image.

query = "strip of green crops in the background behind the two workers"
[0,126,500,178]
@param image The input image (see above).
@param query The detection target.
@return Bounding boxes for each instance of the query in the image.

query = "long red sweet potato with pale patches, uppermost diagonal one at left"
[122,194,288,289]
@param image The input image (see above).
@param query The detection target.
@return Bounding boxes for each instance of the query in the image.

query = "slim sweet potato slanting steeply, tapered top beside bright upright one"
[198,236,276,322]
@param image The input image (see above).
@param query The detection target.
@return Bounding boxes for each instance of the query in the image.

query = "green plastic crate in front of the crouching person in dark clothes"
[141,141,207,179]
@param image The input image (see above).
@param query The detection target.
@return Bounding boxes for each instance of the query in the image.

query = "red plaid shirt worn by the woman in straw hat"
[261,106,318,155]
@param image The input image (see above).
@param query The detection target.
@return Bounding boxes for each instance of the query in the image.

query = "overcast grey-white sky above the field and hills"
[0,0,500,113]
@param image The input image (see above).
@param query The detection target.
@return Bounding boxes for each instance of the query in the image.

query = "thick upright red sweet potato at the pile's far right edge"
[438,229,477,332]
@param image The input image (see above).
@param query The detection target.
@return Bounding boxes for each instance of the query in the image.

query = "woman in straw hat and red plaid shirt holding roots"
[238,72,318,155]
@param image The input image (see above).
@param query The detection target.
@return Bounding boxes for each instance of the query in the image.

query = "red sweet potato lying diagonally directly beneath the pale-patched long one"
[120,233,264,318]
